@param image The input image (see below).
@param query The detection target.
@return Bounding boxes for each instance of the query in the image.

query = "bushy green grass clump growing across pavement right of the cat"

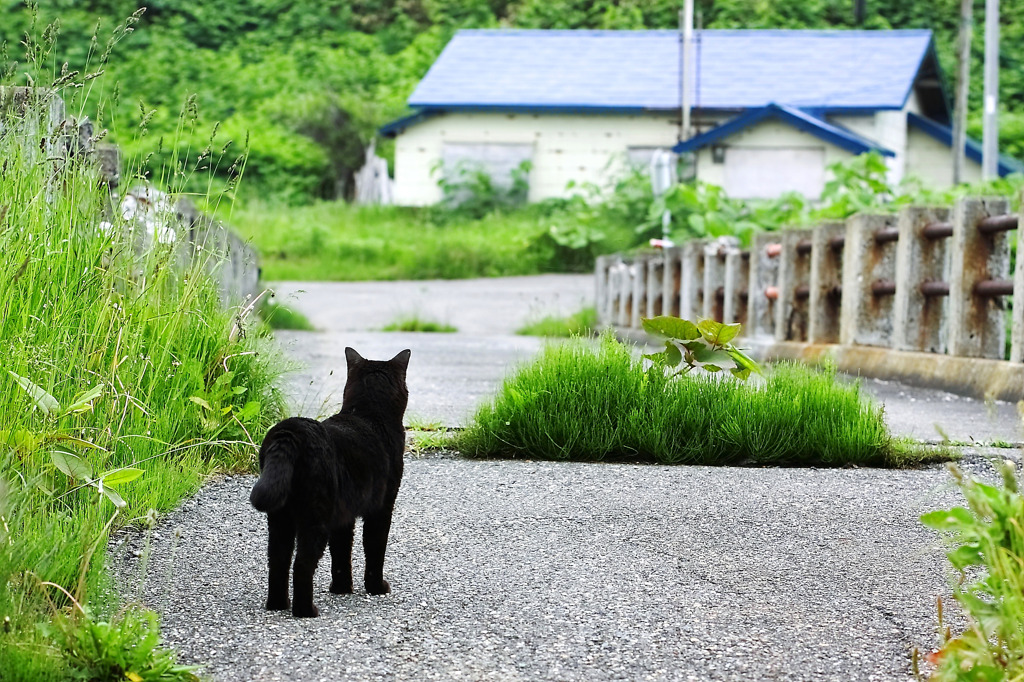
[456,337,908,466]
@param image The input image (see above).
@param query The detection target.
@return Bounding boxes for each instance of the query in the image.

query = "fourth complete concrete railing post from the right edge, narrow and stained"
[807,222,846,343]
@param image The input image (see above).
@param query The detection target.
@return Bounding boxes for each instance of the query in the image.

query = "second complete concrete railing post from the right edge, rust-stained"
[893,206,949,353]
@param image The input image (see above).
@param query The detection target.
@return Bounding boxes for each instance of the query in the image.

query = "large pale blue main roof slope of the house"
[409,29,934,112]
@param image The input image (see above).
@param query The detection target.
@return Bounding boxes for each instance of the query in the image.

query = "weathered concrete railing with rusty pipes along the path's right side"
[596,192,1024,400]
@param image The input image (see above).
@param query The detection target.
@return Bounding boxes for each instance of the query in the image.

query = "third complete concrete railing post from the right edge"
[839,214,897,346]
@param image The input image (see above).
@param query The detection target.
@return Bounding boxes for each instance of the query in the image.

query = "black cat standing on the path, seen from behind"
[249,348,411,617]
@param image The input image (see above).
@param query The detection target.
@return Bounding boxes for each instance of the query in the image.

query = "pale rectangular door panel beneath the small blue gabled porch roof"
[724,146,825,200]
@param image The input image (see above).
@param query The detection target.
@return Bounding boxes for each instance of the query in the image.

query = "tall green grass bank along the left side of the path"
[0,90,282,680]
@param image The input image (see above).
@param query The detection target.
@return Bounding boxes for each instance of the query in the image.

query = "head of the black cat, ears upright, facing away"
[343,348,413,420]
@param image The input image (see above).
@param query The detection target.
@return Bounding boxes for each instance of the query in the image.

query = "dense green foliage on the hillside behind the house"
[0,0,1024,202]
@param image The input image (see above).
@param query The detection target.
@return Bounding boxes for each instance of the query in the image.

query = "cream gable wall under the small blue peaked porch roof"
[697,119,853,199]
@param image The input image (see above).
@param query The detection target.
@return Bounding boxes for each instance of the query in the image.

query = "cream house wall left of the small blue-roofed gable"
[394,113,678,201]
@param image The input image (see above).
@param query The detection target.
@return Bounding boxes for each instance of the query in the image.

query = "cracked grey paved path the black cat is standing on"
[112,276,1020,681]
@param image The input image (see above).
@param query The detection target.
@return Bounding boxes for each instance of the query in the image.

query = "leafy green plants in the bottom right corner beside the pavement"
[922,460,1024,681]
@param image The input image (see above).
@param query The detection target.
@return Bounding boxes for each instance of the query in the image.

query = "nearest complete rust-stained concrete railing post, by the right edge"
[949,197,1010,359]
